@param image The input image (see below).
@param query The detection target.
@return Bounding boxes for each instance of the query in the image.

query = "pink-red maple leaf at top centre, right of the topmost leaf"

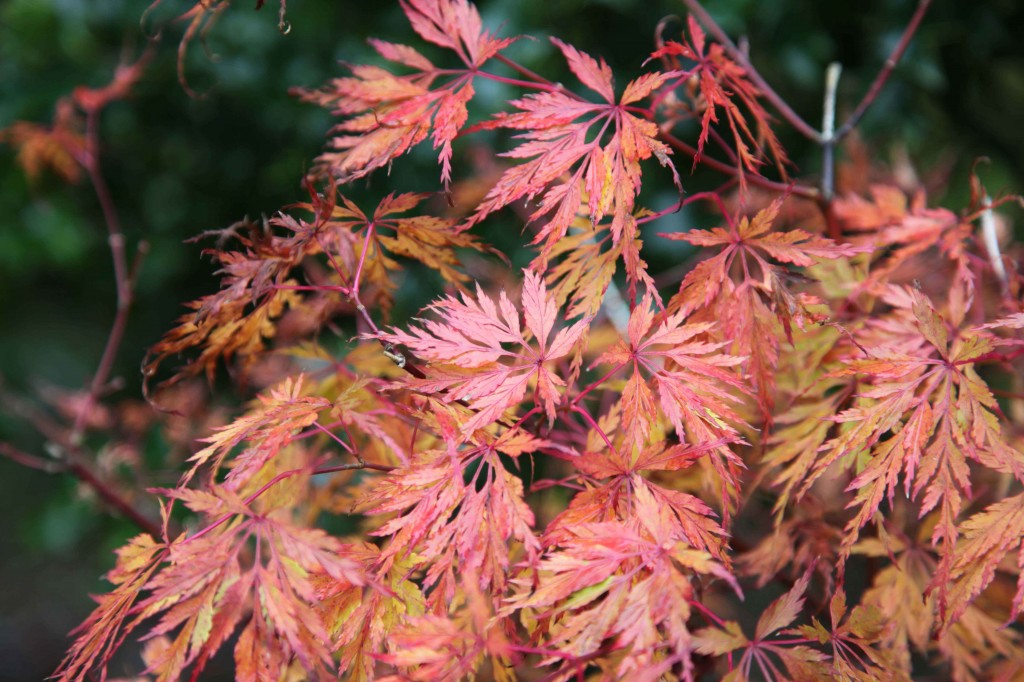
[466,38,681,269]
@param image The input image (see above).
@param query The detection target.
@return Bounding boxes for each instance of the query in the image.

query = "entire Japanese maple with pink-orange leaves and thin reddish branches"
[0,0,1024,681]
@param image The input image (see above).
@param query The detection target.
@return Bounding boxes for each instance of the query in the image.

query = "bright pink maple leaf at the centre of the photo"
[381,270,590,433]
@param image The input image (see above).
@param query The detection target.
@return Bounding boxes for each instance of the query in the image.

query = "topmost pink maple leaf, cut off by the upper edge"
[299,0,515,187]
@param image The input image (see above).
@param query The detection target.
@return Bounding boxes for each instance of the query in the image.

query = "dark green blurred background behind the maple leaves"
[0,0,1024,680]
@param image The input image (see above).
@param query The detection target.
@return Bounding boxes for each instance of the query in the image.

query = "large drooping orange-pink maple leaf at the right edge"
[800,290,1024,554]
